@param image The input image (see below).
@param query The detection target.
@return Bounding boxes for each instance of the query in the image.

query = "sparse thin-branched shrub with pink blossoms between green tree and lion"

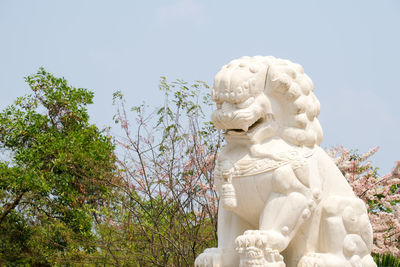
[109,78,222,266]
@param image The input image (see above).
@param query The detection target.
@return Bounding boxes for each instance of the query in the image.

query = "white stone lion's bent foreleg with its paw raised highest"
[236,165,318,267]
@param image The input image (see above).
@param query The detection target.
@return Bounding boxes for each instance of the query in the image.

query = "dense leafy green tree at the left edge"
[0,68,115,266]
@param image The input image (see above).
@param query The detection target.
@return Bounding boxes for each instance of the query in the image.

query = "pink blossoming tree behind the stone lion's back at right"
[327,147,400,258]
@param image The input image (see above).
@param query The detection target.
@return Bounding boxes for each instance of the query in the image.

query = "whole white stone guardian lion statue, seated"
[195,56,376,267]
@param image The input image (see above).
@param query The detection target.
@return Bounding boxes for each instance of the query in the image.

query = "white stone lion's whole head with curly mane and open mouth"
[211,56,322,147]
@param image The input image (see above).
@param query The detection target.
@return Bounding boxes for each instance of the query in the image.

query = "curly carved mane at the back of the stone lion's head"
[265,57,323,147]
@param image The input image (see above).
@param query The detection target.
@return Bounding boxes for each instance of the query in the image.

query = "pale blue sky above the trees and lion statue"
[0,0,400,174]
